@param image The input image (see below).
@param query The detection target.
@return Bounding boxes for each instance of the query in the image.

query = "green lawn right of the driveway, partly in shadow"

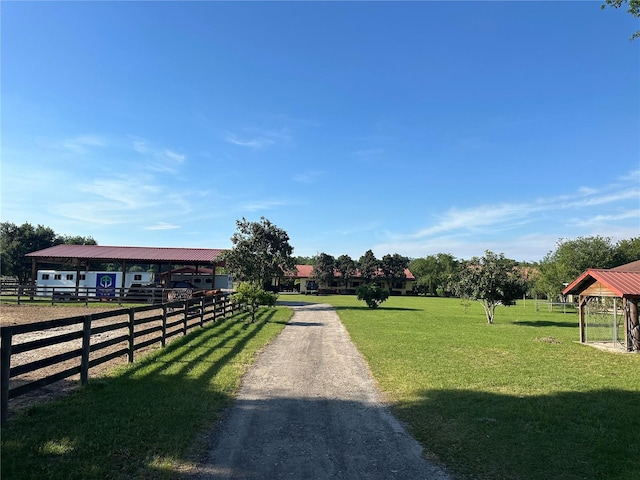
[292,296,640,479]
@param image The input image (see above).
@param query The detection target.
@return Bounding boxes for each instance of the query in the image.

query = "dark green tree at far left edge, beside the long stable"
[0,222,64,285]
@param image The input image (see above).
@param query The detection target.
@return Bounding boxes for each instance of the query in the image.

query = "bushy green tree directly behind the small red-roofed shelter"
[536,236,616,299]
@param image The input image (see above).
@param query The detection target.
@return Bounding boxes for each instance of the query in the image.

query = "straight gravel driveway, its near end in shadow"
[192,305,448,480]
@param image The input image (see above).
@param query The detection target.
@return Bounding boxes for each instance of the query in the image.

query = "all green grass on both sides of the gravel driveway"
[2,295,640,480]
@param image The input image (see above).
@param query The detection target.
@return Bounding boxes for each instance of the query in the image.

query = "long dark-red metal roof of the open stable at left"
[26,244,224,263]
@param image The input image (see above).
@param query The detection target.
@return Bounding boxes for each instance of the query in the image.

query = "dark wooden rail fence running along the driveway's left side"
[0,294,237,423]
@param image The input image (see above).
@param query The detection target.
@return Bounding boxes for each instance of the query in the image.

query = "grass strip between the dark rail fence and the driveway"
[1,308,292,480]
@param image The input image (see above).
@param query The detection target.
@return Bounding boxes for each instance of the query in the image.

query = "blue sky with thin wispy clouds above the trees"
[0,1,640,261]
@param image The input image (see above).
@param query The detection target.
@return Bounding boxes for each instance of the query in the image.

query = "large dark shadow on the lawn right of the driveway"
[394,390,640,479]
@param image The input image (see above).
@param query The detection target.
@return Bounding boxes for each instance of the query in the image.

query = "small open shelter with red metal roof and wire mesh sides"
[562,261,640,352]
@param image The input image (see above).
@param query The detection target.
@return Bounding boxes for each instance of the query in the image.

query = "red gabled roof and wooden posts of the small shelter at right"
[562,261,640,353]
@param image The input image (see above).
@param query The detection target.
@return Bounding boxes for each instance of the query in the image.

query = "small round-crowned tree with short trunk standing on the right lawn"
[455,250,526,324]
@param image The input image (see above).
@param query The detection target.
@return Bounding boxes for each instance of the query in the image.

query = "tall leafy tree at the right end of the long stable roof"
[222,217,295,288]
